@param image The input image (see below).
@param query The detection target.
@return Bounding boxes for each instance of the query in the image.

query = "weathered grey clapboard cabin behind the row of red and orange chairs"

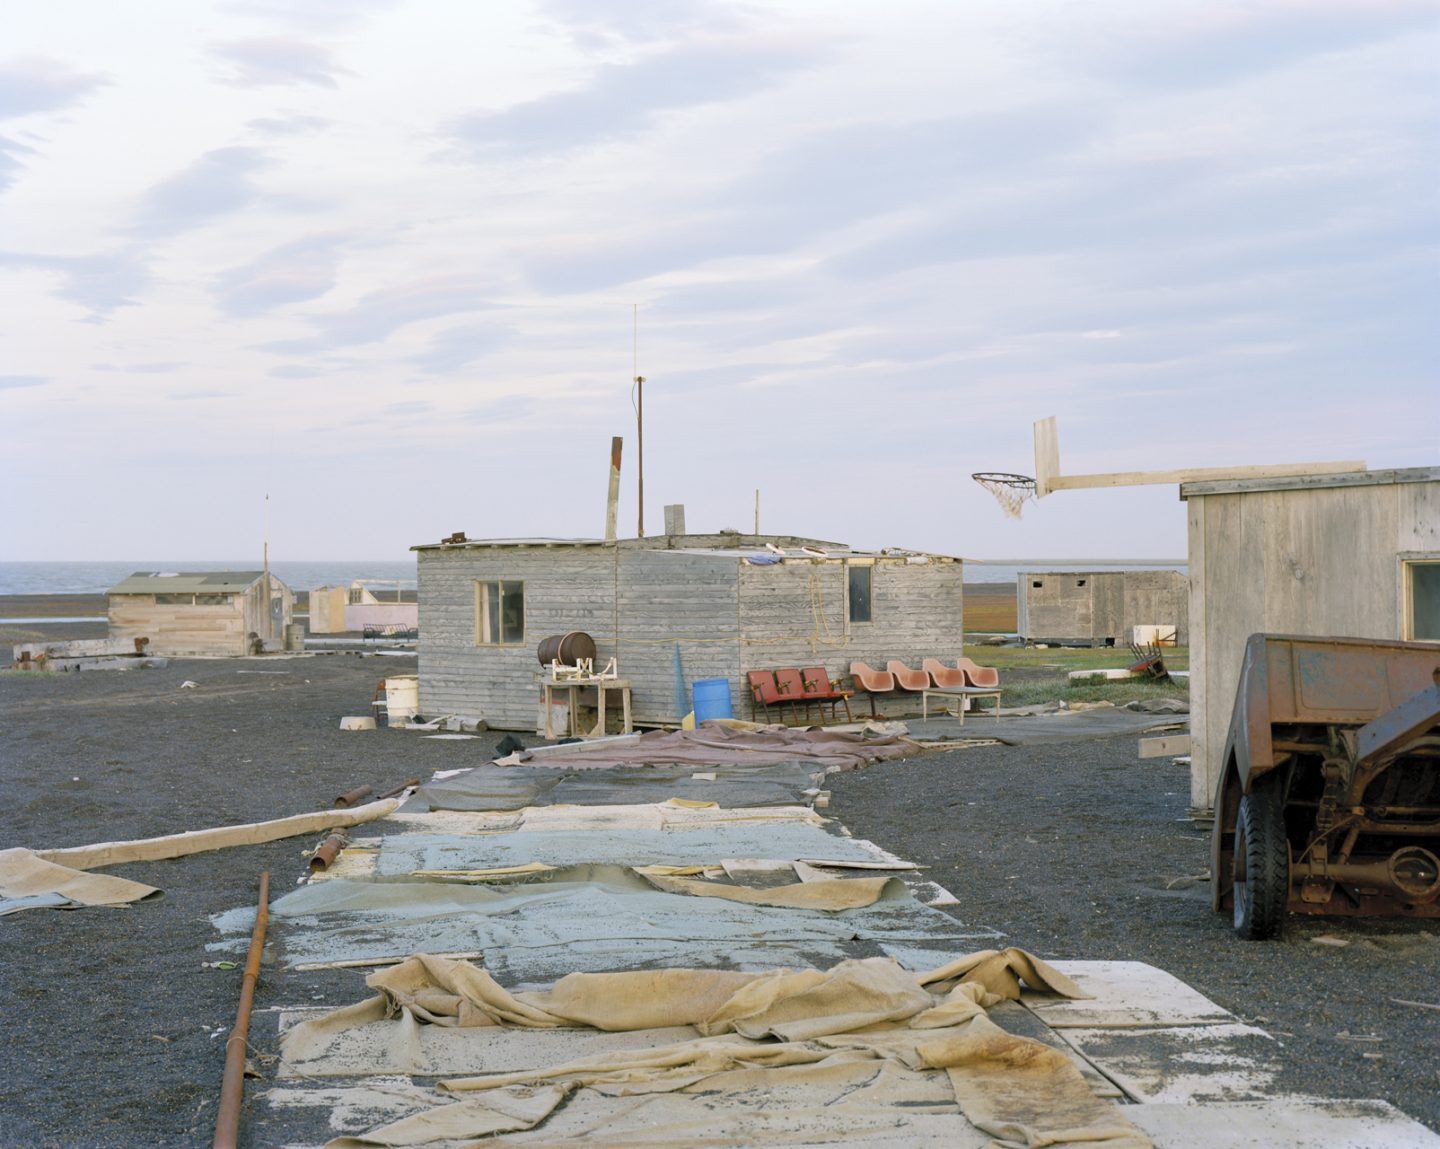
[412,533,963,730]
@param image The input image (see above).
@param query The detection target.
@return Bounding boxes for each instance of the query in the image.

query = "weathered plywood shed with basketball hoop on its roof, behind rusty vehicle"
[1179,467,1440,809]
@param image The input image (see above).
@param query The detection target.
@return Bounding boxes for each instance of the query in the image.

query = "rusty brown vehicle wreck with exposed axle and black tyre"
[1211,635,1440,939]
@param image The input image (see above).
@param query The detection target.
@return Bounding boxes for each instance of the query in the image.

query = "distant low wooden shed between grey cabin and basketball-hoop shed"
[1015,570,1189,646]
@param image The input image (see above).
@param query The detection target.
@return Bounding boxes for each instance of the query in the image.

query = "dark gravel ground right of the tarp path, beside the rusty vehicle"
[828,737,1440,1130]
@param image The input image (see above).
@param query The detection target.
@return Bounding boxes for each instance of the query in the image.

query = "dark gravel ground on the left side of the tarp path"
[0,655,512,1149]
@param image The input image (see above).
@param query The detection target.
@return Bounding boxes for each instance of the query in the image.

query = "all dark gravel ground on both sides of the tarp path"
[0,655,1440,1149]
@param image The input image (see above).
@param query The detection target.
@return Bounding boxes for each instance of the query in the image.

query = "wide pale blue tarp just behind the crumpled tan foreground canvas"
[212,865,996,983]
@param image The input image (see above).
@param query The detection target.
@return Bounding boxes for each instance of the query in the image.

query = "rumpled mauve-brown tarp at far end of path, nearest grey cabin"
[497,723,922,770]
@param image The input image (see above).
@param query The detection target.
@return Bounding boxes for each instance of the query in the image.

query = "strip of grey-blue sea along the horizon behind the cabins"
[0,559,1187,595]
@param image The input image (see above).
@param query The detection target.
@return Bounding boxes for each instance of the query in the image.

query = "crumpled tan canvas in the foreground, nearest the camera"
[282,950,1148,1149]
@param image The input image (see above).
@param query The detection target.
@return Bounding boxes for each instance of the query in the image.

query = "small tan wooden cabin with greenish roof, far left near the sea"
[108,570,295,657]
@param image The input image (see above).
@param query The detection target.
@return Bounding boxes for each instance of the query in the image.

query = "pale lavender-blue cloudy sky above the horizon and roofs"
[0,0,1440,560]
